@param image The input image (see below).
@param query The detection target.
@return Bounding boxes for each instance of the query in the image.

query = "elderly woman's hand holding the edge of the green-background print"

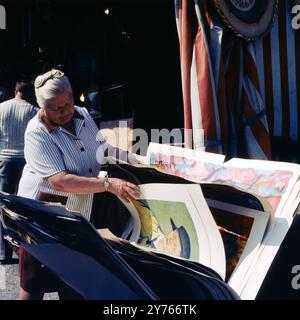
[107,178,141,202]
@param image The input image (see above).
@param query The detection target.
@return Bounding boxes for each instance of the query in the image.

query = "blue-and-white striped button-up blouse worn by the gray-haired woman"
[18,106,103,219]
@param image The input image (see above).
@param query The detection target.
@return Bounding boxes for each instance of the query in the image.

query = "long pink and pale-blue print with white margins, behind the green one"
[147,144,300,215]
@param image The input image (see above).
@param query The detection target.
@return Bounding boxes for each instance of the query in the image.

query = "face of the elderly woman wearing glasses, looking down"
[44,92,74,126]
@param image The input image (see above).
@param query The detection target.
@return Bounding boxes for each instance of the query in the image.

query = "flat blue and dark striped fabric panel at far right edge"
[257,1,300,140]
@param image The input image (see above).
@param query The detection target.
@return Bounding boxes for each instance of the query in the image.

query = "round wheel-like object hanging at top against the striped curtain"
[213,0,279,40]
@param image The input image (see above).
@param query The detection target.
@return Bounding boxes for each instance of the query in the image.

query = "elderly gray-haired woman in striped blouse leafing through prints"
[18,70,143,299]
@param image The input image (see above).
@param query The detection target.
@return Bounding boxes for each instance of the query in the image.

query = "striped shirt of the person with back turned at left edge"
[0,98,38,160]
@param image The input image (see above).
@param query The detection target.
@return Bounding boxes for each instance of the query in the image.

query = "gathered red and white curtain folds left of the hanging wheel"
[175,0,227,153]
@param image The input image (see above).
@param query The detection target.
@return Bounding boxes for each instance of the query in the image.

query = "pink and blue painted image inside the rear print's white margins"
[150,153,293,212]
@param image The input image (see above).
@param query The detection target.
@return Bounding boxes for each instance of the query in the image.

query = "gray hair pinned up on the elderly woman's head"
[34,69,72,108]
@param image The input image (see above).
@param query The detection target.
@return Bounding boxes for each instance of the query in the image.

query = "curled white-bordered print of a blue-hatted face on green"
[118,184,225,279]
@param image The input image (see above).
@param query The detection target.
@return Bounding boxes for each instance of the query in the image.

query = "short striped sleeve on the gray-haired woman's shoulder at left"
[24,131,66,178]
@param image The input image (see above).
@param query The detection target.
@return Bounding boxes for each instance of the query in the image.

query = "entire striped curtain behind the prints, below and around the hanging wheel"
[175,0,300,159]
